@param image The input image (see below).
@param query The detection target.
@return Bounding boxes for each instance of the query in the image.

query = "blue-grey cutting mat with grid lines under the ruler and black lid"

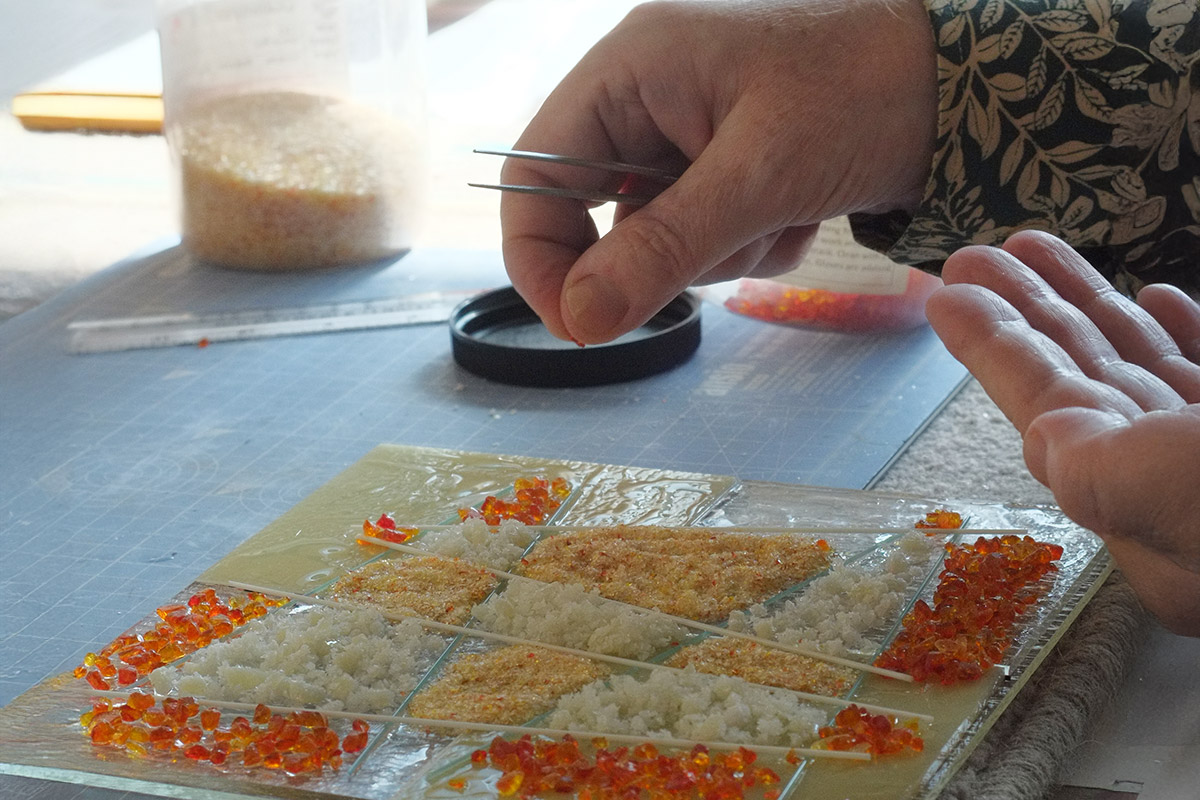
[0,248,965,719]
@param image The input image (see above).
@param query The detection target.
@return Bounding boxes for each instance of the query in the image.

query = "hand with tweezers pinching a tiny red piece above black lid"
[500,0,937,343]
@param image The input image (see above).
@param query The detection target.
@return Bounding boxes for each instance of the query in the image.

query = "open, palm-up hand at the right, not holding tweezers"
[926,231,1200,636]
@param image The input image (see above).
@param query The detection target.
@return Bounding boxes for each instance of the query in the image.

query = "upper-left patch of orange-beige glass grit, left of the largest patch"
[331,555,499,625]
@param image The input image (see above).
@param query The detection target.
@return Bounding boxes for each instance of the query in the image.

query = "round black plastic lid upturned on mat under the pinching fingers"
[450,287,700,387]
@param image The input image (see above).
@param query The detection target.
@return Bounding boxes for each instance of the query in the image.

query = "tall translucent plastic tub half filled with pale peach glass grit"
[158,0,428,270]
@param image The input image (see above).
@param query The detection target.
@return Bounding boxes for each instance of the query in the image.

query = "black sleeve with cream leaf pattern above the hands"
[852,0,1200,293]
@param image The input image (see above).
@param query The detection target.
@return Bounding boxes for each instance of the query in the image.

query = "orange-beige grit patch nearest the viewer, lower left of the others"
[407,645,608,724]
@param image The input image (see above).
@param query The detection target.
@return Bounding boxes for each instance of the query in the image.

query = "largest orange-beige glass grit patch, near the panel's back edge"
[522,525,830,622]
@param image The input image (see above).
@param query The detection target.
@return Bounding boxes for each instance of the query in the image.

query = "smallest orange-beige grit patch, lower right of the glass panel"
[666,637,858,697]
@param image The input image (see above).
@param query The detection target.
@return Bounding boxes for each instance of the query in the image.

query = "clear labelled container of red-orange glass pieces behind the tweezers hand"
[725,218,942,332]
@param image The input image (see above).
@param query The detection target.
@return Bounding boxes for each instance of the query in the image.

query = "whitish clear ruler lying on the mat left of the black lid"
[67,290,479,353]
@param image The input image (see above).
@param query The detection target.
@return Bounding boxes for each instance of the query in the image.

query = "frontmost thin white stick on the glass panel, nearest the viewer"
[91,691,871,762]
